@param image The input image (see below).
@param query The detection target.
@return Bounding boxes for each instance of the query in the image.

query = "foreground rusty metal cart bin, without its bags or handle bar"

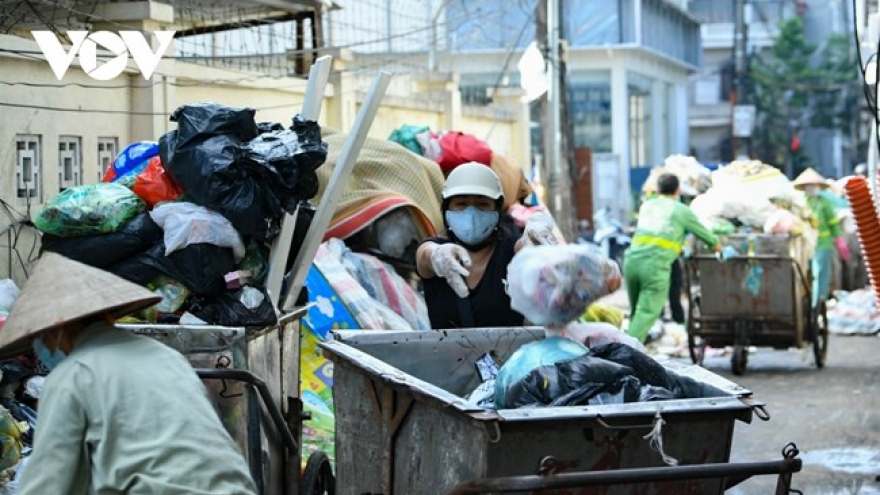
[321,328,784,495]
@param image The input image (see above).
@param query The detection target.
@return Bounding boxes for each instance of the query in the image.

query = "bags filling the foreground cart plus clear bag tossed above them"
[468,245,720,409]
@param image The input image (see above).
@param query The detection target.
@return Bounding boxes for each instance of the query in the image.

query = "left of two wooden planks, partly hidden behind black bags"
[266,55,333,307]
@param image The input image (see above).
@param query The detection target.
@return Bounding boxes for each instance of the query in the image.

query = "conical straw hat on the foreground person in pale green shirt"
[0,252,162,356]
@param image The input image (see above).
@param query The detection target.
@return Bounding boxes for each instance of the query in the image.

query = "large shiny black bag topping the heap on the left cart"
[159,102,327,240]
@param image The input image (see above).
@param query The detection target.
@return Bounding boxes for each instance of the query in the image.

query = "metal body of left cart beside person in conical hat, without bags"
[117,306,334,495]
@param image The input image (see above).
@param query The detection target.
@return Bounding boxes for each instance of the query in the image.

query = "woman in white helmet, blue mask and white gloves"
[416,162,556,328]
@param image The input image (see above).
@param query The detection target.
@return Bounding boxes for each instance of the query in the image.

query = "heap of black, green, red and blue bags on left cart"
[34,102,327,326]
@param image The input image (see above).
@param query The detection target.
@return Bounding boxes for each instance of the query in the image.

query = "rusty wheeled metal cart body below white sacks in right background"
[685,234,828,375]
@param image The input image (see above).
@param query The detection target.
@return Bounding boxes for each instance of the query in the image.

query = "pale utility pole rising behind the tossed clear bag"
[536,0,576,241]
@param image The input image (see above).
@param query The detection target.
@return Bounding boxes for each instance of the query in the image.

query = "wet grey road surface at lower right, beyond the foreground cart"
[704,335,880,495]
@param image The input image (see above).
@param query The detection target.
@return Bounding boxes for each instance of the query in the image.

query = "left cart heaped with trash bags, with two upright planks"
[12,56,391,495]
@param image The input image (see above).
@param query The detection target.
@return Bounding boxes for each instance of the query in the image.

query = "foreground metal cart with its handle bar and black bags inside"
[321,327,801,495]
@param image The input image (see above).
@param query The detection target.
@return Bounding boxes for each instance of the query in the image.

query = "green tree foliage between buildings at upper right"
[749,17,858,170]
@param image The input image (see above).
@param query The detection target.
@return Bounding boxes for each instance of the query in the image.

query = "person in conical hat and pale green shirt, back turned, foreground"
[0,253,256,495]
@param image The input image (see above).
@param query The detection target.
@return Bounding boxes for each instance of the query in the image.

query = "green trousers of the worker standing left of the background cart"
[623,256,672,342]
